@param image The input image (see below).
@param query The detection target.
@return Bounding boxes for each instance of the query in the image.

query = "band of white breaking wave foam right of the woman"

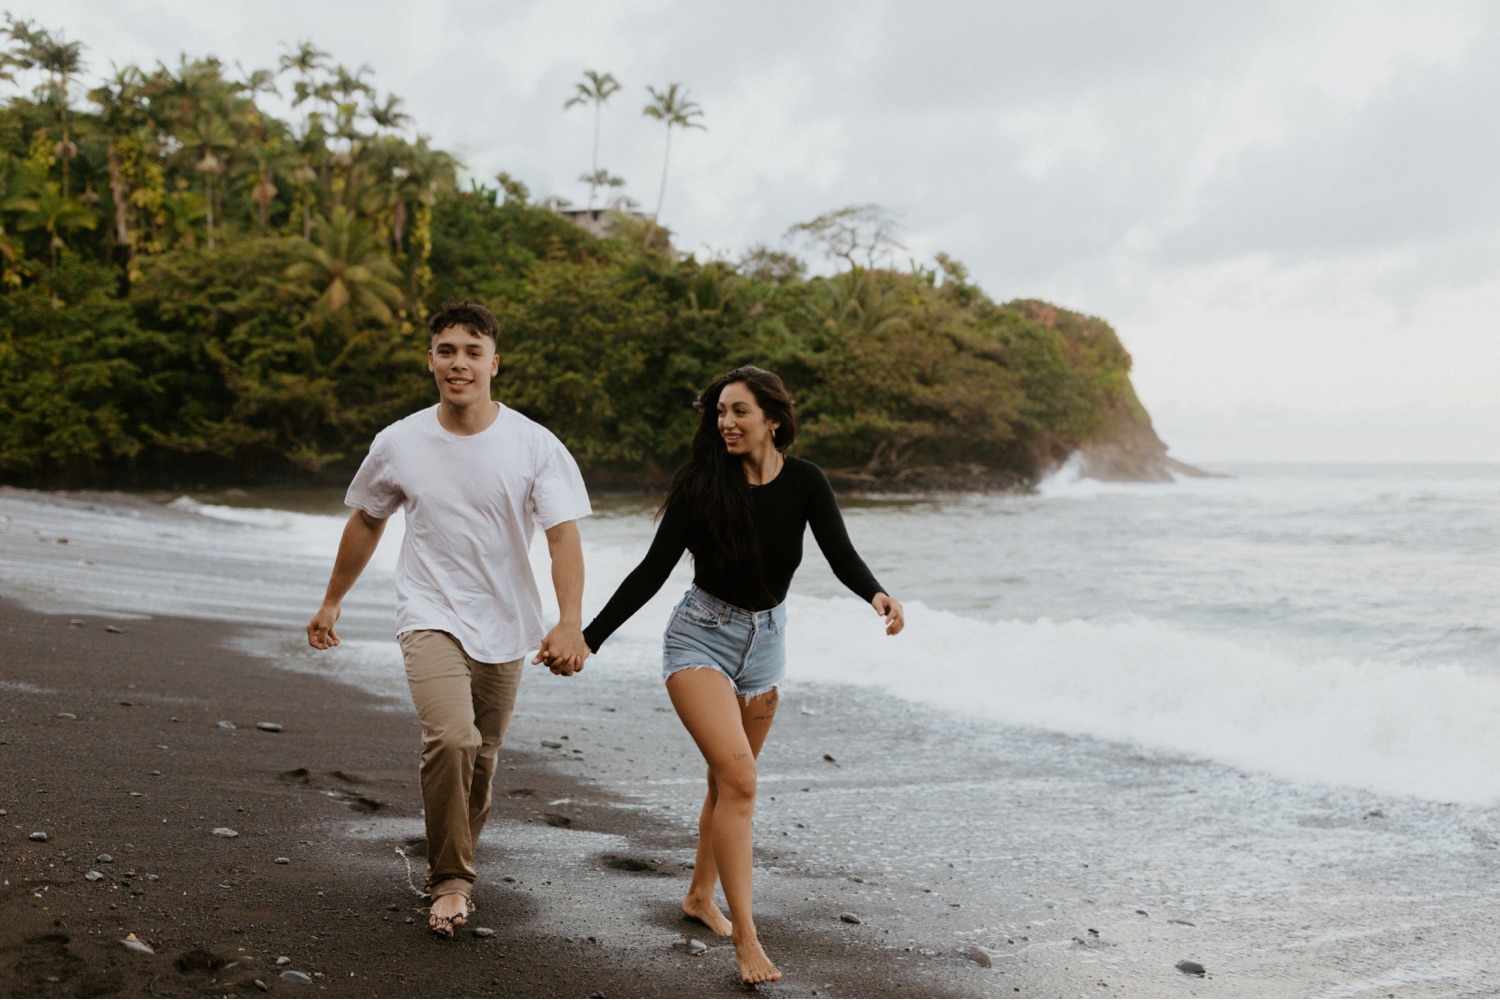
[789,597,1500,805]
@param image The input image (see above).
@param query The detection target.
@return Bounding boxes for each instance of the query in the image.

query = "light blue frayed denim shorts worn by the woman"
[662,586,786,700]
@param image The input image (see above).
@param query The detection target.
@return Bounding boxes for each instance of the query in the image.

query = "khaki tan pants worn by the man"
[401,631,524,897]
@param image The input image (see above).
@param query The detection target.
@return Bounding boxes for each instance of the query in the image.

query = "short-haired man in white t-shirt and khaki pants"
[308,301,591,937]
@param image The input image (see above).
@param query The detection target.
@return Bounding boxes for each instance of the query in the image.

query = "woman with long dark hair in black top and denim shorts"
[584,366,905,984]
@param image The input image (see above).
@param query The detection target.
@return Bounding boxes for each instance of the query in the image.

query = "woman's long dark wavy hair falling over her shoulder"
[662,364,797,607]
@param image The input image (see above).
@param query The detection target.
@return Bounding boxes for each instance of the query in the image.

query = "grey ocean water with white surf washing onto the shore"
[0,465,1500,996]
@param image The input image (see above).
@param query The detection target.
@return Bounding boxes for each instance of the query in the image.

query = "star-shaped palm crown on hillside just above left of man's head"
[285,205,402,324]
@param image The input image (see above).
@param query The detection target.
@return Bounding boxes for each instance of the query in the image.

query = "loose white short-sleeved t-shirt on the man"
[344,406,593,663]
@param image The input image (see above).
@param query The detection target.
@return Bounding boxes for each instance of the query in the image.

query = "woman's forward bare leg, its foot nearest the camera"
[666,670,782,984]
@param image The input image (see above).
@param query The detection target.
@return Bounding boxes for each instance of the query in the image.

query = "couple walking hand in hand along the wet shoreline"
[308,301,905,984]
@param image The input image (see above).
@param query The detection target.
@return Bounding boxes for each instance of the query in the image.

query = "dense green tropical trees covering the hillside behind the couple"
[0,21,1134,486]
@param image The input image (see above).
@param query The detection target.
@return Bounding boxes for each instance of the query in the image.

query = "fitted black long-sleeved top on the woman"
[584,457,885,652]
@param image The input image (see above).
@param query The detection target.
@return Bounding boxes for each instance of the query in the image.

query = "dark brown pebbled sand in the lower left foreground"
[0,600,996,997]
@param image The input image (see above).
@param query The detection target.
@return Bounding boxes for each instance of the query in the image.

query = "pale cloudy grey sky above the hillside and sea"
[8,0,1500,463]
